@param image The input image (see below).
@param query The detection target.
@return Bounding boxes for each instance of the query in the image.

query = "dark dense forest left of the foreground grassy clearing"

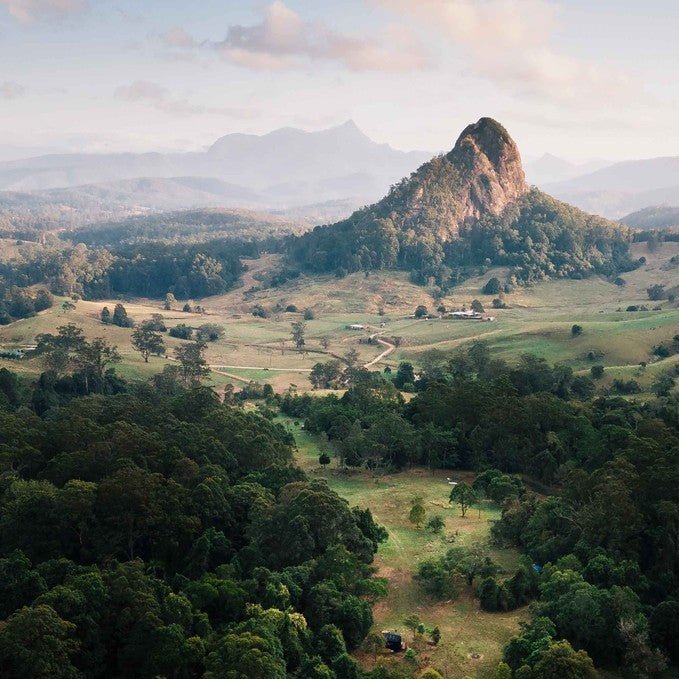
[0,363,385,679]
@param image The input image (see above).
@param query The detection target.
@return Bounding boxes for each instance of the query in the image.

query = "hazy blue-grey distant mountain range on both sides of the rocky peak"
[0,121,679,228]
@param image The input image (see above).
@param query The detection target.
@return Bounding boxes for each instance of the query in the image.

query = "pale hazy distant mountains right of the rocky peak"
[542,156,679,219]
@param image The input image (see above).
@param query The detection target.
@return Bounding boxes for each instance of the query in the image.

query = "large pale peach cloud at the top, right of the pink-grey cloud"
[375,0,639,102]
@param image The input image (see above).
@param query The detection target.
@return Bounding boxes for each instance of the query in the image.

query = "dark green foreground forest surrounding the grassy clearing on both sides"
[0,332,679,679]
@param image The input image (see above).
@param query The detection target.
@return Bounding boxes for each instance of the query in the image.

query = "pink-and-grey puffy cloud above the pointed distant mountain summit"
[163,0,429,72]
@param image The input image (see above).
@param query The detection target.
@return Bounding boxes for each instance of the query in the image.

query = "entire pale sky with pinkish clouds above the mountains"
[0,0,679,160]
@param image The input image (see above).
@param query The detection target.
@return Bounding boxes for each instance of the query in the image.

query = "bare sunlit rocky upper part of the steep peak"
[370,118,528,241]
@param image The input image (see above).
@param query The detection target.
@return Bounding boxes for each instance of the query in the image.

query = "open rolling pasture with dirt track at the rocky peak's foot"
[0,243,679,390]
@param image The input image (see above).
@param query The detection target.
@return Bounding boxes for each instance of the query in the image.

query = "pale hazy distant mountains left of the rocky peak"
[0,121,429,208]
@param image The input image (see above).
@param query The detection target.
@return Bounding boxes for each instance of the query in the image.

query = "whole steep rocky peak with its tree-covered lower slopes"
[290,118,633,287]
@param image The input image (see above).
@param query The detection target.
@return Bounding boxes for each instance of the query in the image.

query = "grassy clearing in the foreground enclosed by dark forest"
[281,418,528,677]
